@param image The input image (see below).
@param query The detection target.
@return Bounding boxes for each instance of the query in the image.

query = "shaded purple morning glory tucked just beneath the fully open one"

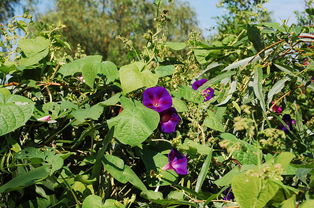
[159,108,181,133]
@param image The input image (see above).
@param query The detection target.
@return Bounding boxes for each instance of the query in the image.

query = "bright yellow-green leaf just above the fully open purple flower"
[119,62,158,94]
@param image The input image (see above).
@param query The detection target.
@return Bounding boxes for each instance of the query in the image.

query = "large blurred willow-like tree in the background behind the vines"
[40,0,197,64]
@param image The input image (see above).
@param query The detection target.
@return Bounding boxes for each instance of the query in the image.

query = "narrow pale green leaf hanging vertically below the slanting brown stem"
[253,67,266,112]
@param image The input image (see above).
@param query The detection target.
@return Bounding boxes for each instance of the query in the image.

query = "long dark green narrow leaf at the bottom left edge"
[0,166,49,193]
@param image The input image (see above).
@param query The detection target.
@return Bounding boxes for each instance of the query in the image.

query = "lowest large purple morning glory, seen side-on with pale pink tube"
[162,149,188,175]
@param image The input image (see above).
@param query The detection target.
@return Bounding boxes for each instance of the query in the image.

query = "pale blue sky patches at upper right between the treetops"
[187,0,304,34]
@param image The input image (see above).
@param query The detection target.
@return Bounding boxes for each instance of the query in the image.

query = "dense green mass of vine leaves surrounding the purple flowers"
[0,1,314,208]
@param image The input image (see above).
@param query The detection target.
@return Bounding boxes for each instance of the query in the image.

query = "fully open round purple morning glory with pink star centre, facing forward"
[143,87,172,112]
